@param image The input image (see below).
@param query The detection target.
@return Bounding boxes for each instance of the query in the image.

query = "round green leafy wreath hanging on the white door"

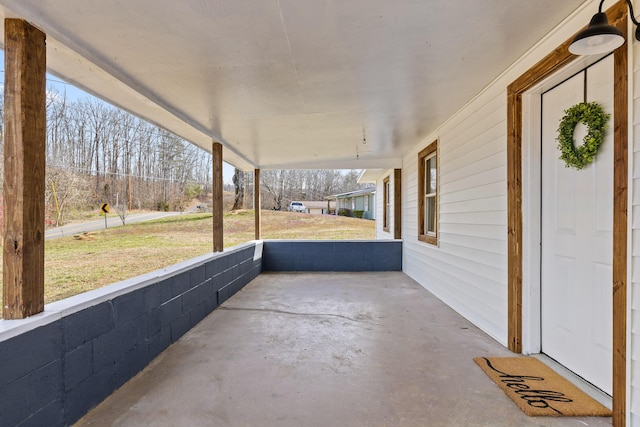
[557,102,611,169]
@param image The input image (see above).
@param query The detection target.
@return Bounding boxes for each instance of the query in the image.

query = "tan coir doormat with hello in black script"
[473,357,611,417]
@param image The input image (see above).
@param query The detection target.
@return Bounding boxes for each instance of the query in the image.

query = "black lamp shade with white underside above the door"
[569,12,624,55]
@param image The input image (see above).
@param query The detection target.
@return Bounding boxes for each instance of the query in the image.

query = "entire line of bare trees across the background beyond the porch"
[0,88,370,226]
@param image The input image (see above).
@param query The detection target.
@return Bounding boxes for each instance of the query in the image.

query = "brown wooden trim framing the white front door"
[507,0,628,426]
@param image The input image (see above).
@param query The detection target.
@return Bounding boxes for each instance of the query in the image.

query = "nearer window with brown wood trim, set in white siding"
[418,141,438,245]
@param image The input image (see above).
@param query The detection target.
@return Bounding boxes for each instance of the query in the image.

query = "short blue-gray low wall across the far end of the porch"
[262,240,402,271]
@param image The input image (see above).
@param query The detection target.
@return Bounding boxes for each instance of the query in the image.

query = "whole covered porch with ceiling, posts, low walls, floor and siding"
[0,0,640,426]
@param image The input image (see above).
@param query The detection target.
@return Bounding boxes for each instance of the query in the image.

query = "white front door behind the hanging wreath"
[540,56,613,394]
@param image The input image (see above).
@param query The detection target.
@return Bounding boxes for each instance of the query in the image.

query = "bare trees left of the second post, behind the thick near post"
[0,89,212,225]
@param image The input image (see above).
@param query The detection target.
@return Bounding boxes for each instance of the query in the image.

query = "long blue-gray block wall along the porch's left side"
[0,243,261,426]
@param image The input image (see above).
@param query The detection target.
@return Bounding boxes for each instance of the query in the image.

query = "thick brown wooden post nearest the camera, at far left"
[2,19,47,319]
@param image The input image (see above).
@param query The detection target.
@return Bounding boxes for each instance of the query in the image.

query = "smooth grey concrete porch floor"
[76,272,611,427]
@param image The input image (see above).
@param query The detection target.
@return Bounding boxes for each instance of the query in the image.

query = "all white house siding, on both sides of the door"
[377,1,640,418]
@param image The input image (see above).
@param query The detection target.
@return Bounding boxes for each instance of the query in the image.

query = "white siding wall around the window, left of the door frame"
[403,92,507,344]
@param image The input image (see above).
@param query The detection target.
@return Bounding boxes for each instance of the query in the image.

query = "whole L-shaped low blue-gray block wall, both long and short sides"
[0,240,402,427]
